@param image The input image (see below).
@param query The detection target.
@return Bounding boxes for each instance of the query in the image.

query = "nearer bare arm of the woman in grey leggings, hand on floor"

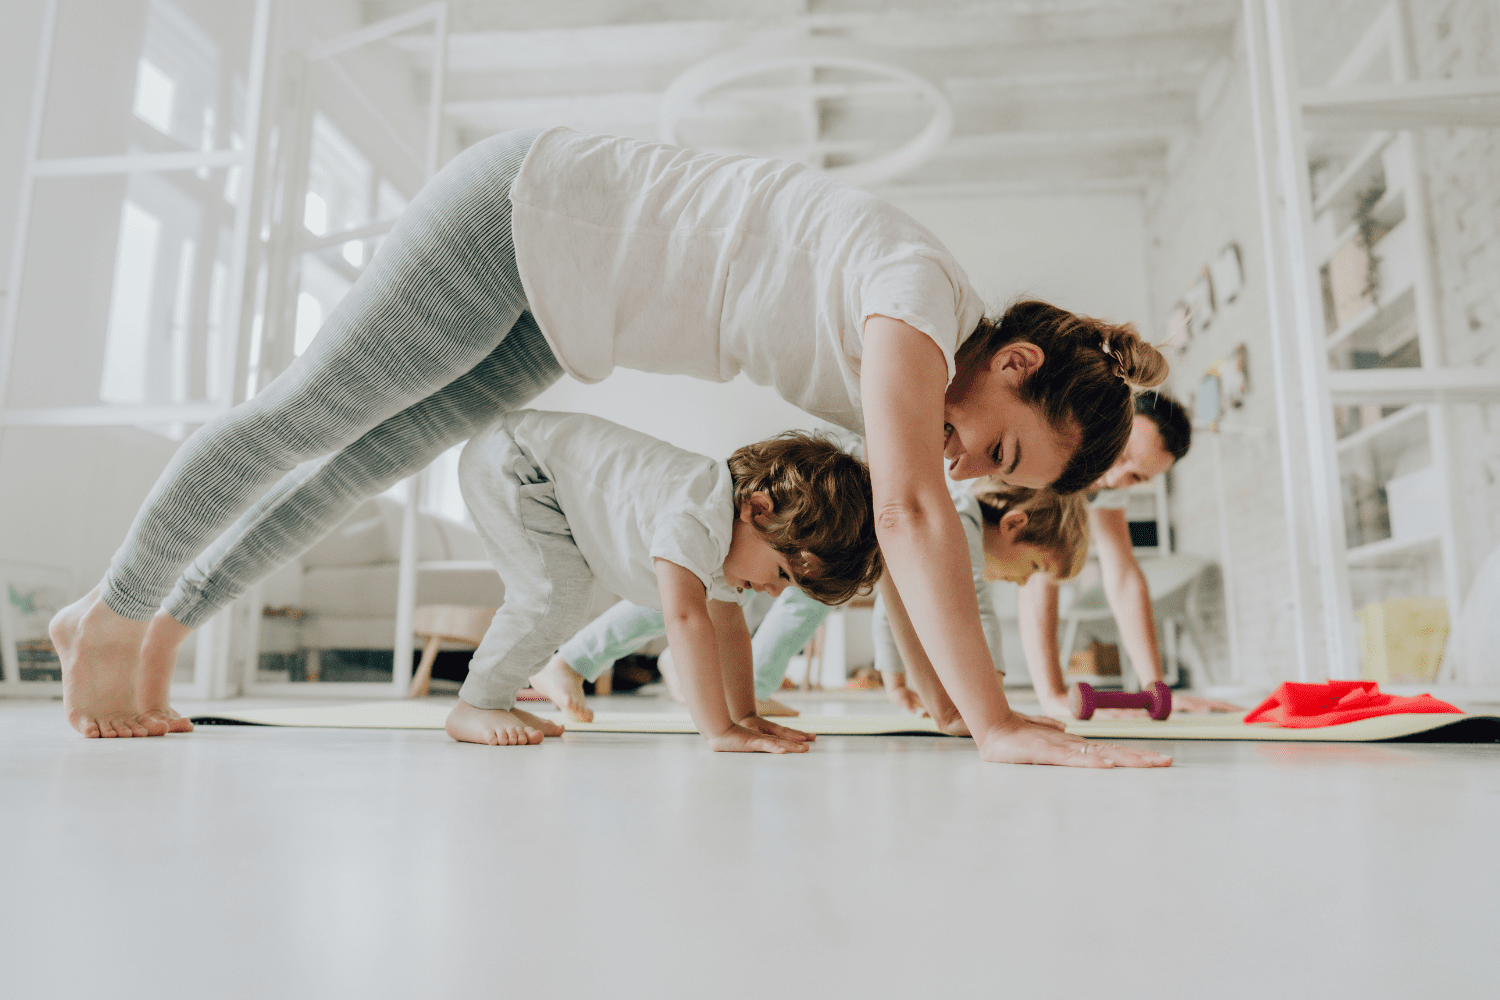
[860,316,1170,766]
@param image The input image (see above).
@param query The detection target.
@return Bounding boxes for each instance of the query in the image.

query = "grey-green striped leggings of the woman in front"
[102,129,563,628]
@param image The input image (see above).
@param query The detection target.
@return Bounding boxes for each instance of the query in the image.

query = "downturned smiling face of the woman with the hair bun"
[942,343,1079,489]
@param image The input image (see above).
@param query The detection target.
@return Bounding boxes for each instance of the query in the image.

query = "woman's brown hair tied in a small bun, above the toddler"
[956,300,1167,495]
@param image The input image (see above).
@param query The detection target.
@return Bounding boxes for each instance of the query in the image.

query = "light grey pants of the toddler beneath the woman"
[459,421,594,709]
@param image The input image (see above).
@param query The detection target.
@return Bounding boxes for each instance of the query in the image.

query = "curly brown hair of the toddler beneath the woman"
[729,430,884,604]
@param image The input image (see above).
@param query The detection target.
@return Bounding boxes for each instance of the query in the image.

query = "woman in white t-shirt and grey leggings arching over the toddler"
[51,129,1170,766]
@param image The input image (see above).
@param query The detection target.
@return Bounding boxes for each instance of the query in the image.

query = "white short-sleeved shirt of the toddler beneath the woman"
[497,409,744,610]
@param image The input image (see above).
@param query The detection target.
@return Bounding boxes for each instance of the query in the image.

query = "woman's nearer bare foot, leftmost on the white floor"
[47,588,167,738]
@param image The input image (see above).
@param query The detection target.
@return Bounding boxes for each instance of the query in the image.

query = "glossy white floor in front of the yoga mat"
[0,694,1500,1000]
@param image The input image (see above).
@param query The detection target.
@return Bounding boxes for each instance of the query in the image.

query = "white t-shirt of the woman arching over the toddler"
[510,129,984,433]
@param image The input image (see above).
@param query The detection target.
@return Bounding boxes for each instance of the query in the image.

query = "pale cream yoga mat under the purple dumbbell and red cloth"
[192,700,1500,744]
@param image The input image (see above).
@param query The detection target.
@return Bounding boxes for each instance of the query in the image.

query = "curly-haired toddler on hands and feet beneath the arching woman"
[447,409,882,753]
